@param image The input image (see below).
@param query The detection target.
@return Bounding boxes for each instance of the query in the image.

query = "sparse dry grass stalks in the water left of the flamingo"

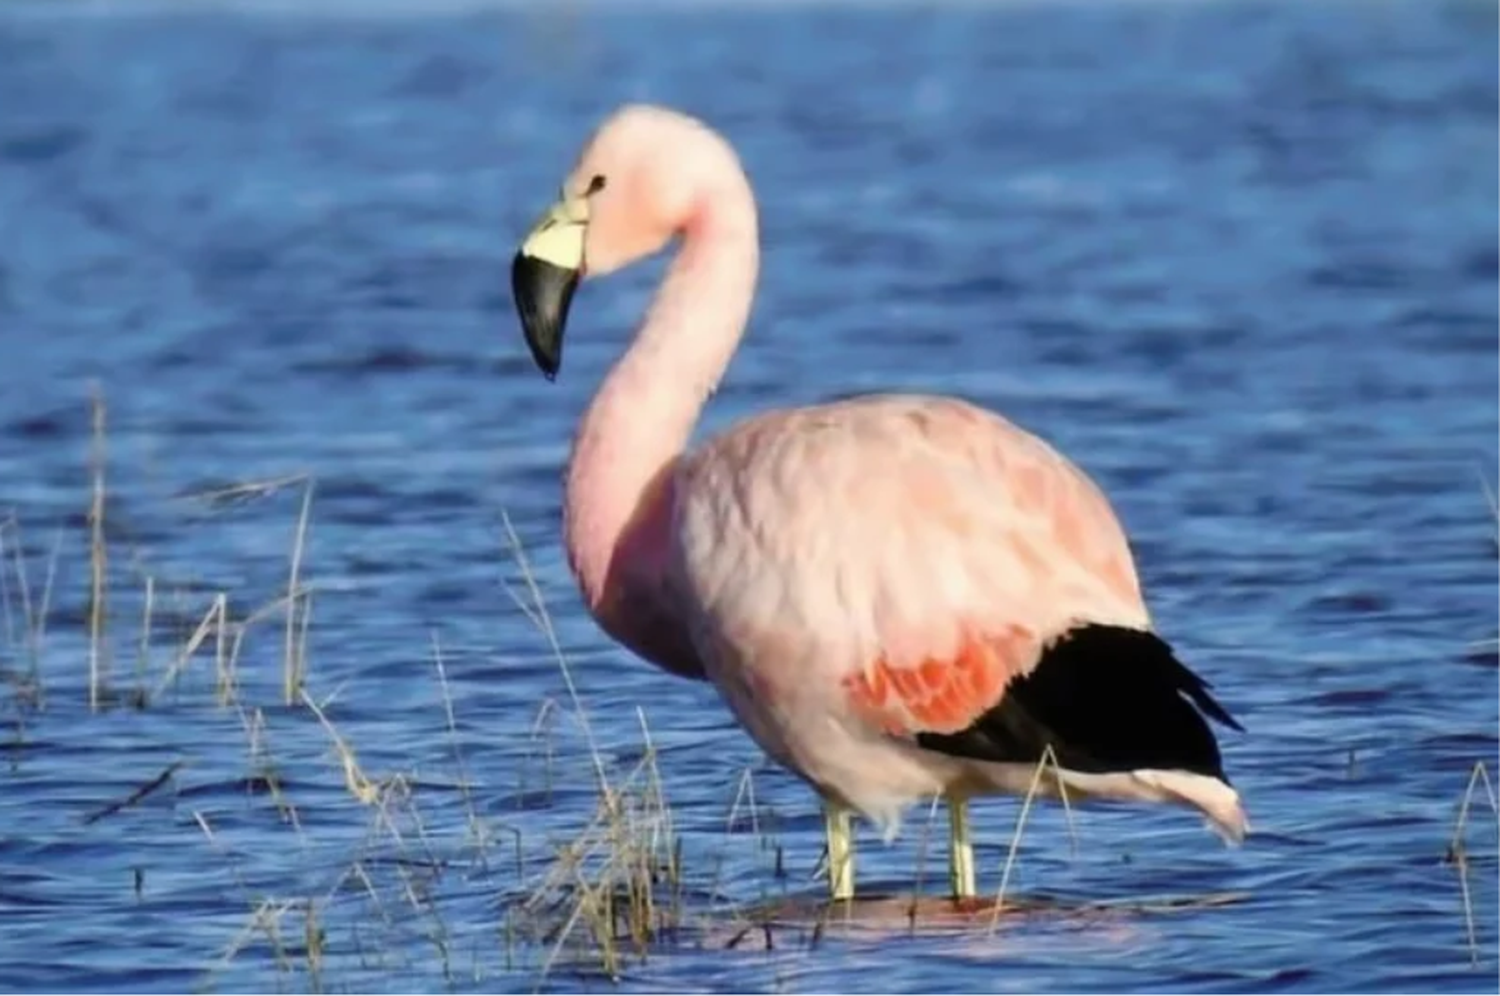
[0,392,738,990]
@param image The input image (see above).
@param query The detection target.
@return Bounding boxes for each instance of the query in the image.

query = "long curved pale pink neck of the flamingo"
[564,174,759,608]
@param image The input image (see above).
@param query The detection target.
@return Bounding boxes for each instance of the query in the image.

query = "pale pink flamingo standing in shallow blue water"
[512,104,1248,900]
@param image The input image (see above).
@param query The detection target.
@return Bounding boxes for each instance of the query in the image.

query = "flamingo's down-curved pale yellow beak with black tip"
[510,198,588,381]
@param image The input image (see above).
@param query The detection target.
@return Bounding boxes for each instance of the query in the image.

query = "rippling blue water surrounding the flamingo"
[0,2,1500,992]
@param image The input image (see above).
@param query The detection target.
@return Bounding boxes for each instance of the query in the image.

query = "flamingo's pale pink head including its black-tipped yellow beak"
[510,105,732,380]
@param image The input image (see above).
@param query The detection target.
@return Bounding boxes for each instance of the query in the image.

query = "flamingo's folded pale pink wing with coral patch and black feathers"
[678,396,1235,777]
